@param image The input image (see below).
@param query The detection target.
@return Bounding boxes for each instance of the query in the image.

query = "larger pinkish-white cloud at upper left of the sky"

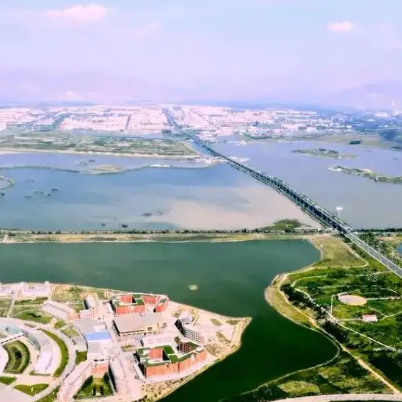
[45,3,109,23]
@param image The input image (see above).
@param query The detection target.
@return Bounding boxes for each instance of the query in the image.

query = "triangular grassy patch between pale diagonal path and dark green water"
[224,352,388,402]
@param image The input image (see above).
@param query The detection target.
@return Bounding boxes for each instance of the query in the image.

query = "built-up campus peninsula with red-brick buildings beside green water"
[0,282,251,402]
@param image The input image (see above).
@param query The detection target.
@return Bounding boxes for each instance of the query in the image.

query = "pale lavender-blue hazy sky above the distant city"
[0,0,402,102]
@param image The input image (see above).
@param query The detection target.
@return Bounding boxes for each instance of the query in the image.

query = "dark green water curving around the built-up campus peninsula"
[0,241,336,402]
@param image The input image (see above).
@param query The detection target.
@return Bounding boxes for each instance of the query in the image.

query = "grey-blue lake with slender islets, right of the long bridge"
[214,141,402,228]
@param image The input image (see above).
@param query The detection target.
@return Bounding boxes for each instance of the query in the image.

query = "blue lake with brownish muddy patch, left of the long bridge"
[0,153,317,230]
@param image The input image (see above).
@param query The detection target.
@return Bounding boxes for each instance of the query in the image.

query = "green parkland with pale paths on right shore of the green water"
[248,236,402,402]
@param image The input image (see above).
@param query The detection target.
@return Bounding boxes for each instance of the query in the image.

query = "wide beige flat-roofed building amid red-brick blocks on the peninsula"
[114,312,167,336]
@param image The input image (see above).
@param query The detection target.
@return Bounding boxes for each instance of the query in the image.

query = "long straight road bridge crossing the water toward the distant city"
[162,109,402,278]
